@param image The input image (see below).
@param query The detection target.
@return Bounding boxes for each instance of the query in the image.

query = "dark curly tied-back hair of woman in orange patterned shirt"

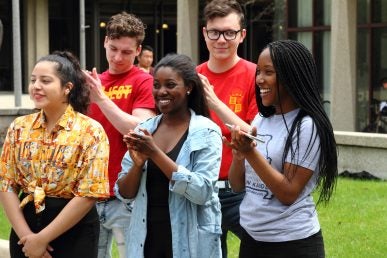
[36,51,90,114]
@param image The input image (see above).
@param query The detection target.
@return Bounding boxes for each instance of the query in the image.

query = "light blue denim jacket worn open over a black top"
[114,110,222,258]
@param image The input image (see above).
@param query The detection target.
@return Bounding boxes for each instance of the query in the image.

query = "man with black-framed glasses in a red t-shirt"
[197,0,258,257]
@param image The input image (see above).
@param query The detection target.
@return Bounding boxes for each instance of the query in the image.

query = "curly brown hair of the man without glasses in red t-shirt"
[106,12,146,46]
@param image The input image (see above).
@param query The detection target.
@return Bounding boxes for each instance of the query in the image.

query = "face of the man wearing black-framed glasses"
[203,13,246,60]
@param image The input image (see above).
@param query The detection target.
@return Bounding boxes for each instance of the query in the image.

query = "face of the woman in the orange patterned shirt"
[28,61,71,111]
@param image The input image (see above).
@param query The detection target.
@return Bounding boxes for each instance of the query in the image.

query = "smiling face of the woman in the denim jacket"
[153,66,191,114]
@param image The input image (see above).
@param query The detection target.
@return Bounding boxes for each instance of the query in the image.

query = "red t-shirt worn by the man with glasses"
[196,59,258,180]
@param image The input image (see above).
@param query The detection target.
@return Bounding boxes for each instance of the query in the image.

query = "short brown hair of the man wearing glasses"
[203,0,245,29]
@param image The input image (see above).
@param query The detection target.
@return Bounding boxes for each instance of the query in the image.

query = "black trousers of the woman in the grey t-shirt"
[239,231,325,258]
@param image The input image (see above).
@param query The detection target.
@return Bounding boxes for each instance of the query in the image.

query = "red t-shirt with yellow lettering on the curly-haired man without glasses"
[88,66,155,195]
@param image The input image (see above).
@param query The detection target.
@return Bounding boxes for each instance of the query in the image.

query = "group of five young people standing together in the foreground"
[0,0,337,258]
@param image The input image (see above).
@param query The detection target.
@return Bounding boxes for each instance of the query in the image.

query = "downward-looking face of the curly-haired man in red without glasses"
[104,37,141,74]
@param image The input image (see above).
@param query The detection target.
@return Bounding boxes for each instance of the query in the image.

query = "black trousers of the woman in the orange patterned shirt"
[9,196,99,258]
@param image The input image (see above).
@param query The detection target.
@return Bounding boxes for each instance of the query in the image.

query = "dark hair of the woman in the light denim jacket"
[154,53,210,117]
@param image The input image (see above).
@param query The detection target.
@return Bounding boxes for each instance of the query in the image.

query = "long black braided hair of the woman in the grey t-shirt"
[256,40,338,203]
